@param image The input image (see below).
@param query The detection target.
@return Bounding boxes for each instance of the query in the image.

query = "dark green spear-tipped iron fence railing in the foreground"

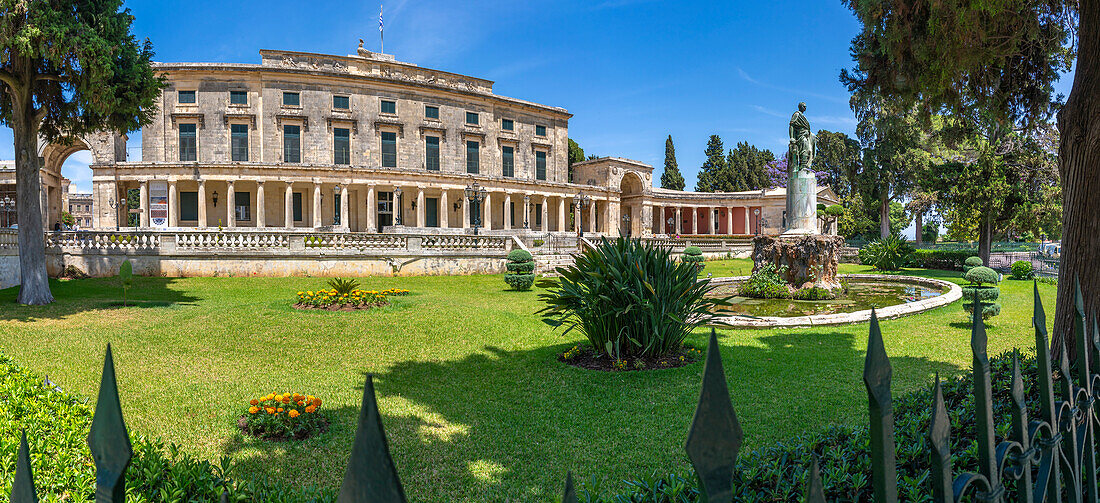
[11,280,1100,503]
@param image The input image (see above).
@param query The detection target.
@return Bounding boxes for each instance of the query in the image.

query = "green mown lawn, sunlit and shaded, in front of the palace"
[0,260,1055,502]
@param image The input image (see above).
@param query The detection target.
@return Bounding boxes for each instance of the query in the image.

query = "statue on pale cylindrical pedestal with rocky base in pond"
[752,102,844,289]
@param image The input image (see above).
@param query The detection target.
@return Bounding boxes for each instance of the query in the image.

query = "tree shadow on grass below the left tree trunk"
[0,276,199,321]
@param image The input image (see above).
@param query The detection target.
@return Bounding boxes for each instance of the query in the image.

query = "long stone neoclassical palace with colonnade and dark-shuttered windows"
[25,43,836,236]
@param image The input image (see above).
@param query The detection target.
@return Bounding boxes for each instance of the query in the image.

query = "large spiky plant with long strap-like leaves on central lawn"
[539,238,729,360]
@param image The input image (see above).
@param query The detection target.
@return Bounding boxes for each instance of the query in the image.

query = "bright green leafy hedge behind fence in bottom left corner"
[0,353,336,503]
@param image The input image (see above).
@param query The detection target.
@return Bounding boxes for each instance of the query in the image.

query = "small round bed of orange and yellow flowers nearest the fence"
[237,393,329,440]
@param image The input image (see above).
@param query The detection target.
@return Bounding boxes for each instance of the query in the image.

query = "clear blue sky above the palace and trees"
[0,0,1070,205]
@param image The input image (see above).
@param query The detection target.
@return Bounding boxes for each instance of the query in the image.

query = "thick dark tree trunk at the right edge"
[1051,0,1100,359]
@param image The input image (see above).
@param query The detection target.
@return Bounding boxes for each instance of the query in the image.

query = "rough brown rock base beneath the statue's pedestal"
[752,234,844,289]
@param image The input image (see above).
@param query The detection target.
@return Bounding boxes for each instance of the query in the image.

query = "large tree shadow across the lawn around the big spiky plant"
[212,330,959,501]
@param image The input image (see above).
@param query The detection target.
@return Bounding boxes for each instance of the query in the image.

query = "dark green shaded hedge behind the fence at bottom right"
[578,352,1040,503]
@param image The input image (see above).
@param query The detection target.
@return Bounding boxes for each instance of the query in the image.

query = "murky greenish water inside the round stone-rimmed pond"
[714,282,943,317]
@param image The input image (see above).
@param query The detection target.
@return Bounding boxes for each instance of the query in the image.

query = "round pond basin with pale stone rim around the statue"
[711,274,963,328]
